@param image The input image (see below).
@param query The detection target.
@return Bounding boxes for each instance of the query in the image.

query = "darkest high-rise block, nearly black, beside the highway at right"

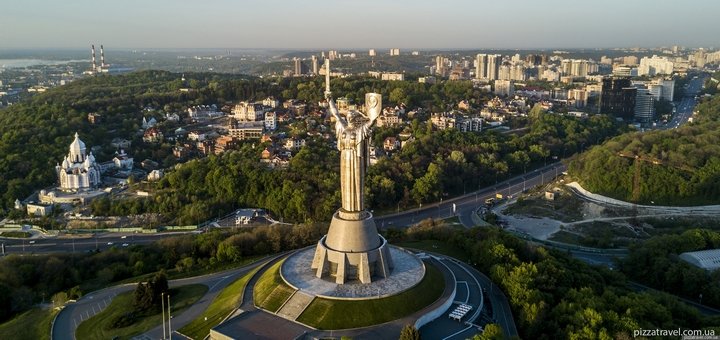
[600,78,637,121]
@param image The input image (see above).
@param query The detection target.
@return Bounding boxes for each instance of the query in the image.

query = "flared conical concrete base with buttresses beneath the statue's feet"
[311,211,394,284]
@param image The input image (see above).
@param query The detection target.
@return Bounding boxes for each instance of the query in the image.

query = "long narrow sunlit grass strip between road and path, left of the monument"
[179,267,260,339]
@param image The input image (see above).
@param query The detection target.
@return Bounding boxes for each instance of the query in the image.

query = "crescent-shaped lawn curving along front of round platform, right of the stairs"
[297,265,445,329]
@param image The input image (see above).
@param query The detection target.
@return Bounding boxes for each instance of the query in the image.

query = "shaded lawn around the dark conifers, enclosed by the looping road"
[75,284,208,339]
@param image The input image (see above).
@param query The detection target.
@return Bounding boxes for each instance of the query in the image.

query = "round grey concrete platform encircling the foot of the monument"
[280,246,425,300]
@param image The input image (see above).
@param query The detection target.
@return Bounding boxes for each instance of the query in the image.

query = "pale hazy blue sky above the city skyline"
[0,0,720,50]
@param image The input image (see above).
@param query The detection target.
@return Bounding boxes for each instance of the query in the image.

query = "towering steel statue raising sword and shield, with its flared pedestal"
[312,60,393,284]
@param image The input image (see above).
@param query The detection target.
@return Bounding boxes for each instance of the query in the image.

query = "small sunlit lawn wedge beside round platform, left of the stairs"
[253,260,295,313]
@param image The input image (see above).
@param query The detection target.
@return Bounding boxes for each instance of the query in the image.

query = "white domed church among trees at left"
[55,133,100,191]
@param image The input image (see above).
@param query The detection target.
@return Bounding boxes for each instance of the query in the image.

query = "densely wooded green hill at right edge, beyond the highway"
[569,86,720,205]
